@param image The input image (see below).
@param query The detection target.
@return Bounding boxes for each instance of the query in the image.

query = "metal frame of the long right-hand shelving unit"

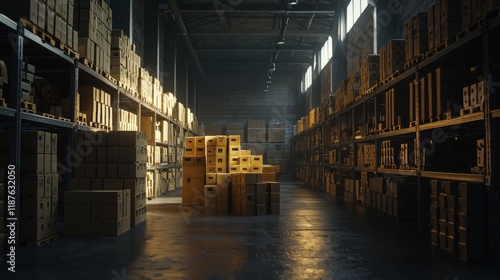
[291,10,500,259]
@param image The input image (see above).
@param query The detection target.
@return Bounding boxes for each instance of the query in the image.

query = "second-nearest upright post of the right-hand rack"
[414,64,425,231]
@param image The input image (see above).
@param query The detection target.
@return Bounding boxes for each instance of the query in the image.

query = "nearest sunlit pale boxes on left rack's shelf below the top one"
[78,87,113,130]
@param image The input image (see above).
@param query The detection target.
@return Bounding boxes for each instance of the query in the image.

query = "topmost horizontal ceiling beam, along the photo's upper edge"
[180,3,337,14]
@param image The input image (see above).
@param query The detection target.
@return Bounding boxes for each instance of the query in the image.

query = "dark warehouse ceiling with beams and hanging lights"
[165,0,338,75]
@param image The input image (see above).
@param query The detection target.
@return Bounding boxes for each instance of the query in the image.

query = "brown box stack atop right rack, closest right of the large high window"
[380,39,406,81]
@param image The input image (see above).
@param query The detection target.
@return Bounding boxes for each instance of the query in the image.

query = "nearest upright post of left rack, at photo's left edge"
[7,22,24,253]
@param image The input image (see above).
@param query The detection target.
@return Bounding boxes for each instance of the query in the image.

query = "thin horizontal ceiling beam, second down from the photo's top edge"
[189,29,333,37]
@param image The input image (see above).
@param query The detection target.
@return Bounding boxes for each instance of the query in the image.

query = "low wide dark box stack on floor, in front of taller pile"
[64,189,133,237]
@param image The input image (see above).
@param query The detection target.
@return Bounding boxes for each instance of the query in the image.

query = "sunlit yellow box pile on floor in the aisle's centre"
[182,135,277,214]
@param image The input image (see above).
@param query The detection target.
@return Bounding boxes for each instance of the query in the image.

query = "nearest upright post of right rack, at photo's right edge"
[483,18,500,261]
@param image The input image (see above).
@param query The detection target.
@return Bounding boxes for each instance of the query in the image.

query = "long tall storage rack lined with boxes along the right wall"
[291,11,500,259]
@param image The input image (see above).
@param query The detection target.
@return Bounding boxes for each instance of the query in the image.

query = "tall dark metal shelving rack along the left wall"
[0,14,195,203]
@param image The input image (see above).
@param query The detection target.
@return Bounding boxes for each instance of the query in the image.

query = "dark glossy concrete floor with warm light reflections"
[0,183,500,280]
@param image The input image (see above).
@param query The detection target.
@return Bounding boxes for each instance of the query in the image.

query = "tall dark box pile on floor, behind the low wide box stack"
[70,131,148,226]
